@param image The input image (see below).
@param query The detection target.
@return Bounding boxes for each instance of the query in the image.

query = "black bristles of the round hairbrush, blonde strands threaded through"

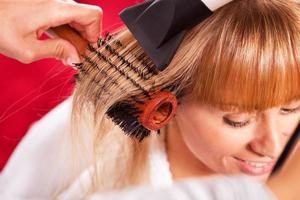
[75,33,173,141]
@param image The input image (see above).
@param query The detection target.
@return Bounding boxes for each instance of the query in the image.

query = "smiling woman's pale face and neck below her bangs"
[167,100,300,181]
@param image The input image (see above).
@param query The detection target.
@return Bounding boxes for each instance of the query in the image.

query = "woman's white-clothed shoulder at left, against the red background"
[0,97,72,198]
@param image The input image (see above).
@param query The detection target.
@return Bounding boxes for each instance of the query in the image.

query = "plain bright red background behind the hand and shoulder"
[0,0,142,171]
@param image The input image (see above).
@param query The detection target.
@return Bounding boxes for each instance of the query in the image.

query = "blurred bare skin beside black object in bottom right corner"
[267,143,300,200]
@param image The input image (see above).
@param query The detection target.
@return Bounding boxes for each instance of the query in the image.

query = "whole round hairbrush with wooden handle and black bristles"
[51,25,177,141]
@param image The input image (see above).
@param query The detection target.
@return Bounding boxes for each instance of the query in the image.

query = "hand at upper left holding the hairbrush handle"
[0,0,102,65]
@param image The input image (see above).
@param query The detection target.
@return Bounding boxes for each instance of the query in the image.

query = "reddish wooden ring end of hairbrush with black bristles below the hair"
[106,91,177,141]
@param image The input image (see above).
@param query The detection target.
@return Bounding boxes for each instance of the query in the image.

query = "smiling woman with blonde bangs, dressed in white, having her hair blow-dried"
[0,0,300,198]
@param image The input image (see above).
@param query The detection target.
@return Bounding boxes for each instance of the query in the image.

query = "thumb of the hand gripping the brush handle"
[32,38,80,66]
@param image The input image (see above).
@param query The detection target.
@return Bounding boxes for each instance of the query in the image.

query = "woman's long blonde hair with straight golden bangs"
[69,0,300,192]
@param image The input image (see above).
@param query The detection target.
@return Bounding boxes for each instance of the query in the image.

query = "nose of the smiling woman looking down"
[250,116,282,158]
